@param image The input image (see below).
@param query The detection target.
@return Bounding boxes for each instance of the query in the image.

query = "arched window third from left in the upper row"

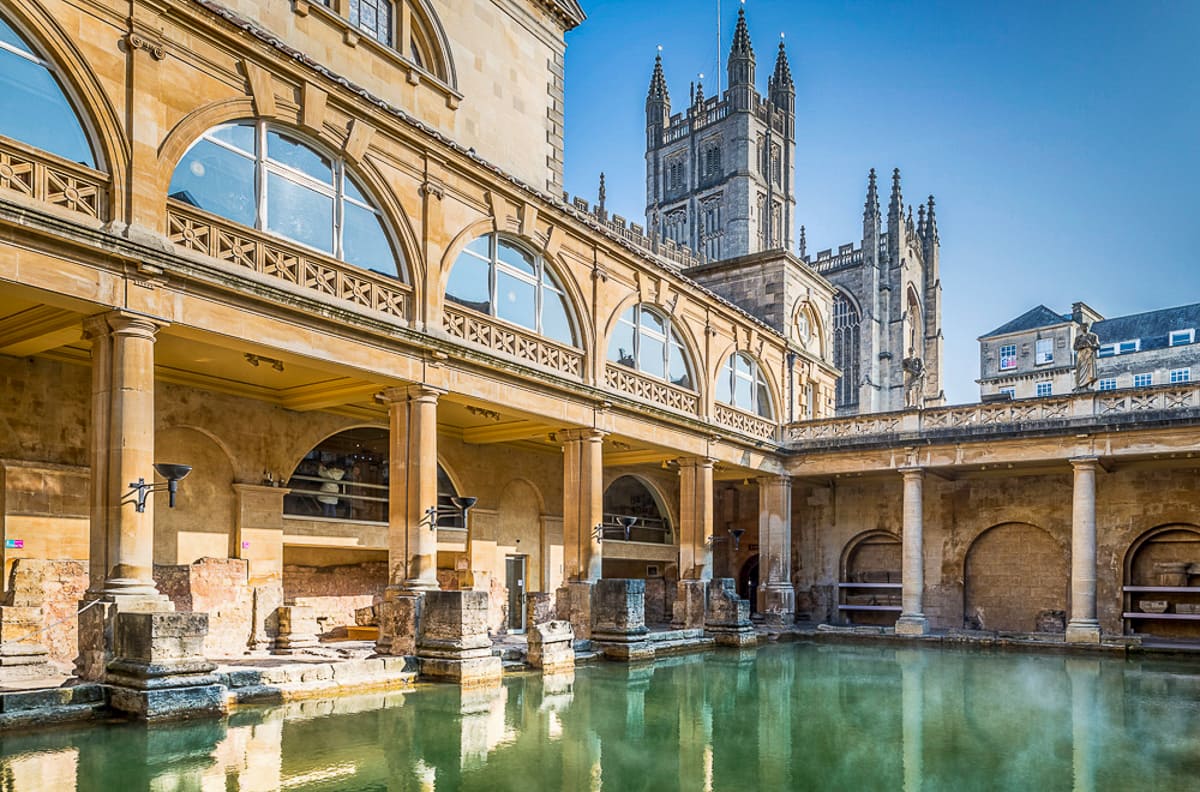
[446,234,576,347]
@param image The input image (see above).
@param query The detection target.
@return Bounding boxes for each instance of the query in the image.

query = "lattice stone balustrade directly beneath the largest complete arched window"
[167,199,412,319]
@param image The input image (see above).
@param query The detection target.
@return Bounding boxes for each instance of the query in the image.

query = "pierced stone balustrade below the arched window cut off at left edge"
[0,137,110,220]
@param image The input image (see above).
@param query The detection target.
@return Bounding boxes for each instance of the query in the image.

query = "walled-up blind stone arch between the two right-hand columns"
[962,522,1070,632]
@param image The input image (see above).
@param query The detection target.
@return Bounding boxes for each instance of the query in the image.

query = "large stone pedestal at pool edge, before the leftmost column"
[106,613,227,720]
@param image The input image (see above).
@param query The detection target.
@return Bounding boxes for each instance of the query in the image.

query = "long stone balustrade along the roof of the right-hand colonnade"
[786,383,1200,445]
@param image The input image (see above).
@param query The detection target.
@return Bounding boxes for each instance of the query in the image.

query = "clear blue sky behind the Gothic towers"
[565,0,1200,403]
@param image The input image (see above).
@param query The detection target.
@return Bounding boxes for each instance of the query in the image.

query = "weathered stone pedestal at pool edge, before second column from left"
[416,592,503,685]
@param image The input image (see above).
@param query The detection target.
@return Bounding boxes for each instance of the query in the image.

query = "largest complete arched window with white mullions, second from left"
[169,120,402,278]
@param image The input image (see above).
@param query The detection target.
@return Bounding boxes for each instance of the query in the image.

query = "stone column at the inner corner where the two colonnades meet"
[758,475,796,626]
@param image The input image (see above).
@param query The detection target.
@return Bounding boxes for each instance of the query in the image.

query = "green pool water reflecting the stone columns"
[0,644,1200,792]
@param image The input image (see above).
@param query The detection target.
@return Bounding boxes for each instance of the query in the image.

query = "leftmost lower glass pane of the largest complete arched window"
[168,139,257,226]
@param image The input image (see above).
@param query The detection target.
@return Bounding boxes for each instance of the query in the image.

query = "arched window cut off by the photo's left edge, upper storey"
[0,14,96,168]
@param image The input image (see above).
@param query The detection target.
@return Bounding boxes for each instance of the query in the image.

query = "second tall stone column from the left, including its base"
[376,384,445,655]
